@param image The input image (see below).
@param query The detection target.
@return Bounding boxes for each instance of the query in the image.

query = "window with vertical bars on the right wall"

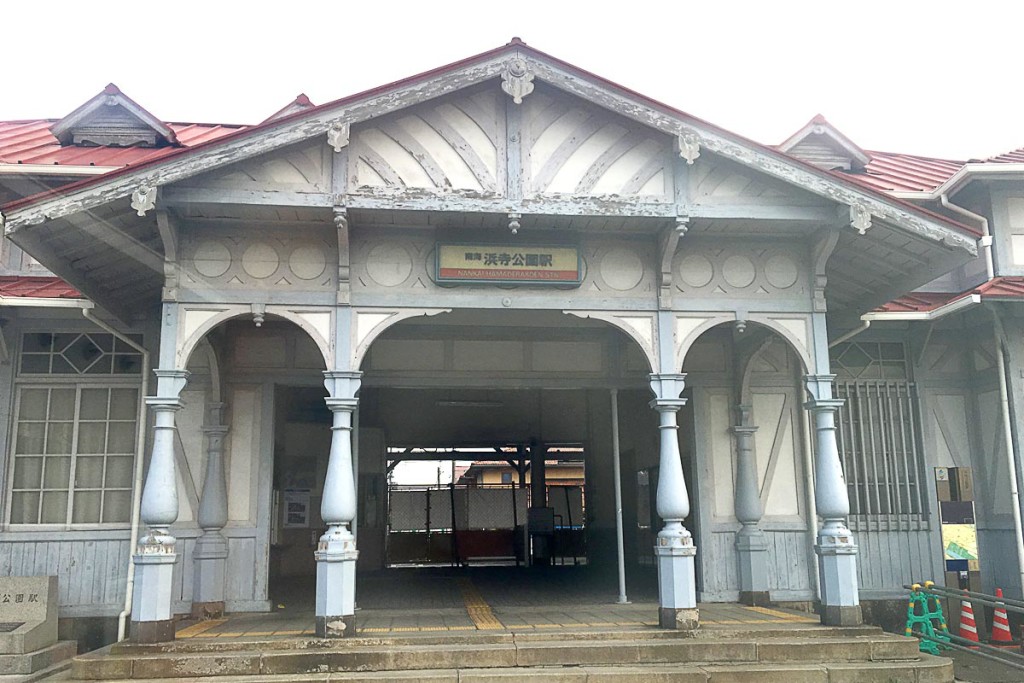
[833,342,928,528]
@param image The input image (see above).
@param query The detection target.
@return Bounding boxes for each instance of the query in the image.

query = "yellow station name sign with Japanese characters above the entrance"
[436,244,582,285]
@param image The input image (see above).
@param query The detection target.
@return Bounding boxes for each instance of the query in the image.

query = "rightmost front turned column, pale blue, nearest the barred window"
[804,375,861,626]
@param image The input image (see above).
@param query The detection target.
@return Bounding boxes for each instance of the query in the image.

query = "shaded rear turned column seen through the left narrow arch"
[193,402,227,618]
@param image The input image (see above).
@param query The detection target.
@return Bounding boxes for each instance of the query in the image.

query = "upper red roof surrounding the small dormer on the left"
[0,119,245,166]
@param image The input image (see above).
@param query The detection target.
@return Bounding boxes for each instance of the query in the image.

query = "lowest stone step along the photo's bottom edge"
[59,654,953,683]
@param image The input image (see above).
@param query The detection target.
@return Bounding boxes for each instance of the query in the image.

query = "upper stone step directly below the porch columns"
[73,631,937,683]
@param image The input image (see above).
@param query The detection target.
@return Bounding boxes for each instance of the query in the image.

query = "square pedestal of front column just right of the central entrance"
[654,527,697,629]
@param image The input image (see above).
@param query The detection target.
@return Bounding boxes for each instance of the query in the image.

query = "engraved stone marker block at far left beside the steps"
[0,577,57,654]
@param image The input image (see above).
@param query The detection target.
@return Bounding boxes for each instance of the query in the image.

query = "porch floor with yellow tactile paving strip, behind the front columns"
[176,567,818,639]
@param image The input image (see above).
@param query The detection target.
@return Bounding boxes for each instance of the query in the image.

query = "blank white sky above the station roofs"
[0,0,1024,159]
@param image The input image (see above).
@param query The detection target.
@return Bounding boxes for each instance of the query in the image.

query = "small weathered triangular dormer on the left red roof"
[50,83,178,147]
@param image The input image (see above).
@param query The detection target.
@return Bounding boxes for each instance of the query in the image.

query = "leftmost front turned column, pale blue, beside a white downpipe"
[131,370,188,643]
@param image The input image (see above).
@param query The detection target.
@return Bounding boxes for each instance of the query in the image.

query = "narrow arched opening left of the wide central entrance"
[176,314,331,615]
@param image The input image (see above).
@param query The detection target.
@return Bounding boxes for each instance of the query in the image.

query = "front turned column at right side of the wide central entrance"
[650,374,697,629]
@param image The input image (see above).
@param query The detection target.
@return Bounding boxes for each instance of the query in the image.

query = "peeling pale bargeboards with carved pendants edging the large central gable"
[4,39,977,259]
